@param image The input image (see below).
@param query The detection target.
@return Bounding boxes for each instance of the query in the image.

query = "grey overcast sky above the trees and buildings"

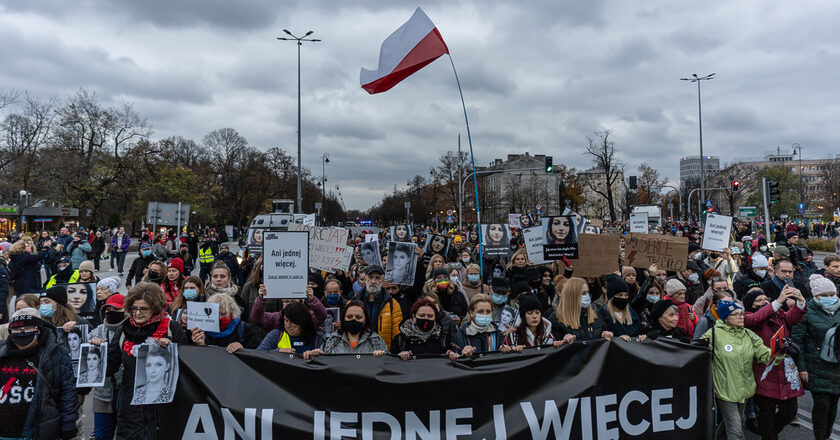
[0,0,840,209]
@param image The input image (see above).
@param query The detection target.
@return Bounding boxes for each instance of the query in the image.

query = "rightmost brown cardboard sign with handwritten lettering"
[624,234,688,271]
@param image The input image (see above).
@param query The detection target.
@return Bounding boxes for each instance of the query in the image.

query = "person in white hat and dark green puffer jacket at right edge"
[792,274,840,440]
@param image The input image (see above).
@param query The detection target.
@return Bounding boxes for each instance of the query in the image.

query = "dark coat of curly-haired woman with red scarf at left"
[108,319,188,440]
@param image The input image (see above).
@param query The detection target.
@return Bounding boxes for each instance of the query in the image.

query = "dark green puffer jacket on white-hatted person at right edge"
[791,299,840,394]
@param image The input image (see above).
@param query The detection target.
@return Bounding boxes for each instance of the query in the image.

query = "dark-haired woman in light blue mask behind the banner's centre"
[452,293,511,357]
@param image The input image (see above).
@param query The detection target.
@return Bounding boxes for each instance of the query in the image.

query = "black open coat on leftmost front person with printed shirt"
[0,322,79,439]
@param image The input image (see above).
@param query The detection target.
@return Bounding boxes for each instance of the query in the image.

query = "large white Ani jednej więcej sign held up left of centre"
[263,230,308,299]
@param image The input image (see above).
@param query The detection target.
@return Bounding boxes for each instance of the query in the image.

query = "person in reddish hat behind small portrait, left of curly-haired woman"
[88,292,127,439]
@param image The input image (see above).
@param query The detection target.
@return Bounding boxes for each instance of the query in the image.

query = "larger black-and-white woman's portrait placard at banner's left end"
[131,343,178,405]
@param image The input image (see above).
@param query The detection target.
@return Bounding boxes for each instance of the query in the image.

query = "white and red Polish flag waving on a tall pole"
[359,8,449,95]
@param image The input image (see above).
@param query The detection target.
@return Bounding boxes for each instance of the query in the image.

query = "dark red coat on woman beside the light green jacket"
[744,302,808,400]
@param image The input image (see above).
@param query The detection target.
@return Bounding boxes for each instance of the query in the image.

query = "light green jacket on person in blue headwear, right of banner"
[701,320,770,403]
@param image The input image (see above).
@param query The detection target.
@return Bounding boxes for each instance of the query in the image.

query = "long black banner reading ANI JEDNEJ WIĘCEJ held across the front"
[157,339,713,440]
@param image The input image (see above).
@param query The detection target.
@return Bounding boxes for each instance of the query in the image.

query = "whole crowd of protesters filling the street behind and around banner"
[0,217,840,439]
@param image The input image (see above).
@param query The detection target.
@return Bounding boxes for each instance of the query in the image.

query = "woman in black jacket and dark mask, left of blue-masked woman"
[391,297,458,361]
